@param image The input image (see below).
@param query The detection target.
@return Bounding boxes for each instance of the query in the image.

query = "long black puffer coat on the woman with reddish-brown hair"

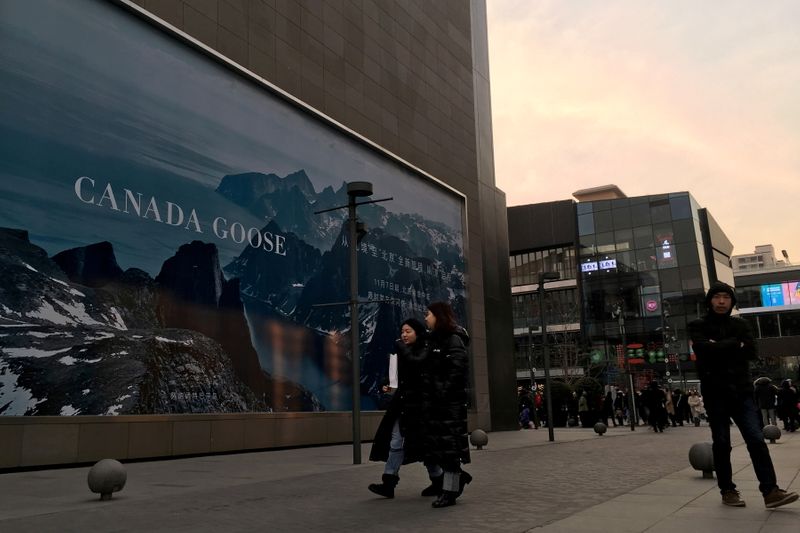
[418,328,470,471]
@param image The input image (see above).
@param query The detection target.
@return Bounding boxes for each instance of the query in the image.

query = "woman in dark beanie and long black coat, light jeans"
[368,318,443,498]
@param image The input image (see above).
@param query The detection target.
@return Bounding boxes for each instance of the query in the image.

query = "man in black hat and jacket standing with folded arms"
[689,282,798,509]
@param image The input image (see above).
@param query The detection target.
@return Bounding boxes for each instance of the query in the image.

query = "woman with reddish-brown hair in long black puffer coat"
[425,302,472,508]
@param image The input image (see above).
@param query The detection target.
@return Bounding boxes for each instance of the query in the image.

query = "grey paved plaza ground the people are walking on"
[0,426,800,533]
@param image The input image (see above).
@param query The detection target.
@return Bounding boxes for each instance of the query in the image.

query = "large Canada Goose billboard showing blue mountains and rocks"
[0,0,466,415]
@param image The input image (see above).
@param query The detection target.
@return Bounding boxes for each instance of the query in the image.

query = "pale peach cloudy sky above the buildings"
[486,0,800,265]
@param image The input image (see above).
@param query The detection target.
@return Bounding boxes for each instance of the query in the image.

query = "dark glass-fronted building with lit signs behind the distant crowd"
[509,189,733,387]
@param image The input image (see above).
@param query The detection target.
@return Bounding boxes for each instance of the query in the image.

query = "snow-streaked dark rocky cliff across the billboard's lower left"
[0,228,321,415]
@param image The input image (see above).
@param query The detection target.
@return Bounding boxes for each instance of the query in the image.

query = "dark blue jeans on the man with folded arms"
[704,391,778,496]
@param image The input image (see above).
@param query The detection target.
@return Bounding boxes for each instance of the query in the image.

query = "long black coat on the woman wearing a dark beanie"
[369,339,434,464]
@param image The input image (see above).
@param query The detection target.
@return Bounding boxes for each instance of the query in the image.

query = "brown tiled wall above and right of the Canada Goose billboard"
[125,0,515,429]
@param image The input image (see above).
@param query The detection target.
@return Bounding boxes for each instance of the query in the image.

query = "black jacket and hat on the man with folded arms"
[688,282,757,396]
